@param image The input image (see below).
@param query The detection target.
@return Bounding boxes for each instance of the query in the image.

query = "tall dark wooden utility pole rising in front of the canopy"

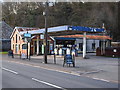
[44,1,48,64]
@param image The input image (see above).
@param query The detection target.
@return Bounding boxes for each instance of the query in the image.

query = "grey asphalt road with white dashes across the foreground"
[1,60,118,89]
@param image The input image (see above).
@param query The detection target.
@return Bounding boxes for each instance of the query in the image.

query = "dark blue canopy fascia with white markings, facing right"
[68,26,104,32]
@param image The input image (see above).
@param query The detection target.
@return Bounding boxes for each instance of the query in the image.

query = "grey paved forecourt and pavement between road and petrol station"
[2,53,119,83]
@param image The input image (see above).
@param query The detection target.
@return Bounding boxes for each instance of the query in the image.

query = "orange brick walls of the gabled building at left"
[11,30,53,54]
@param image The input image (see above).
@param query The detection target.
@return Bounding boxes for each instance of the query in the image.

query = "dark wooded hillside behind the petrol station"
[2,2,120,41]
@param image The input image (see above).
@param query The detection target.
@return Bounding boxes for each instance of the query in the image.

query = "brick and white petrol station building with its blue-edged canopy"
[10,25,111,57]
